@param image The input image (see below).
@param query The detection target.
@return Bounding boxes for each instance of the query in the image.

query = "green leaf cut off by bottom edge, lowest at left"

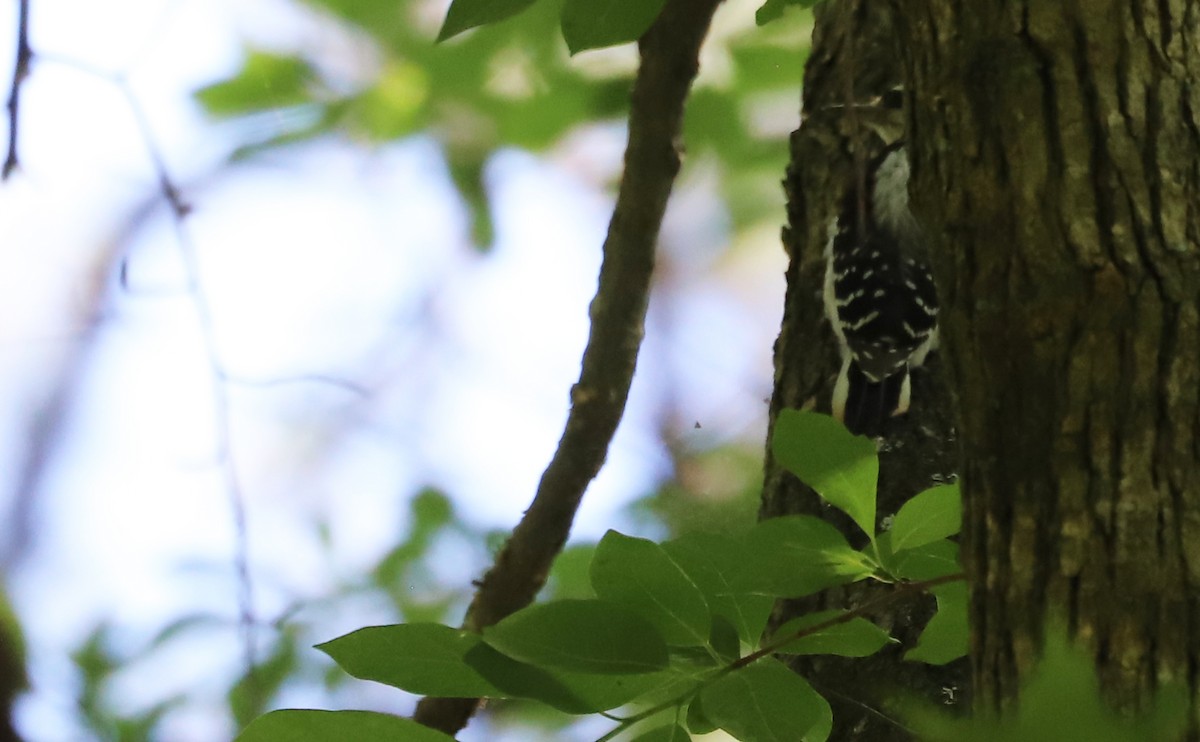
[235,708,454,742]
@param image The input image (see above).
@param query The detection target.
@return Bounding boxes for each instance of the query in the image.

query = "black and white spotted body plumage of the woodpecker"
[824,143,937,435]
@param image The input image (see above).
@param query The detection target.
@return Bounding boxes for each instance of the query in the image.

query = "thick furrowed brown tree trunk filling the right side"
[902,0,1200,720]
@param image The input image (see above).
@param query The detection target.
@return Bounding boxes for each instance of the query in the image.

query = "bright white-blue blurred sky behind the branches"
[0,0,784,742]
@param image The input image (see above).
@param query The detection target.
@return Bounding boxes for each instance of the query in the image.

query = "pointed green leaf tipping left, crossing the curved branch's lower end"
[317,623,503,698]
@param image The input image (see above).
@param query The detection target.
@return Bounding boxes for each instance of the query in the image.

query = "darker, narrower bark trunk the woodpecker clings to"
[761,0,970,742]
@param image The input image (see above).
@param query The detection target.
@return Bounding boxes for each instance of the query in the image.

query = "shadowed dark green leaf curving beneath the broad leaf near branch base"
[464,644,673,713]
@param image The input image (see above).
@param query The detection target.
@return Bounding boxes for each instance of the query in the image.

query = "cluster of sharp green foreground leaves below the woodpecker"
[239,412,966,742]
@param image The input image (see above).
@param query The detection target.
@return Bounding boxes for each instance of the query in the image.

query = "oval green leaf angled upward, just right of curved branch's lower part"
[590,531,712,647]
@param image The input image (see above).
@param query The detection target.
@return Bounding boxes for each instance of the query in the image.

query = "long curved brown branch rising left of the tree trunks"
[414,0,720,735]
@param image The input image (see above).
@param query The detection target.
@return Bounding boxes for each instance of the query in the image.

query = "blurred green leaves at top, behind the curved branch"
[196,0,809,246]
